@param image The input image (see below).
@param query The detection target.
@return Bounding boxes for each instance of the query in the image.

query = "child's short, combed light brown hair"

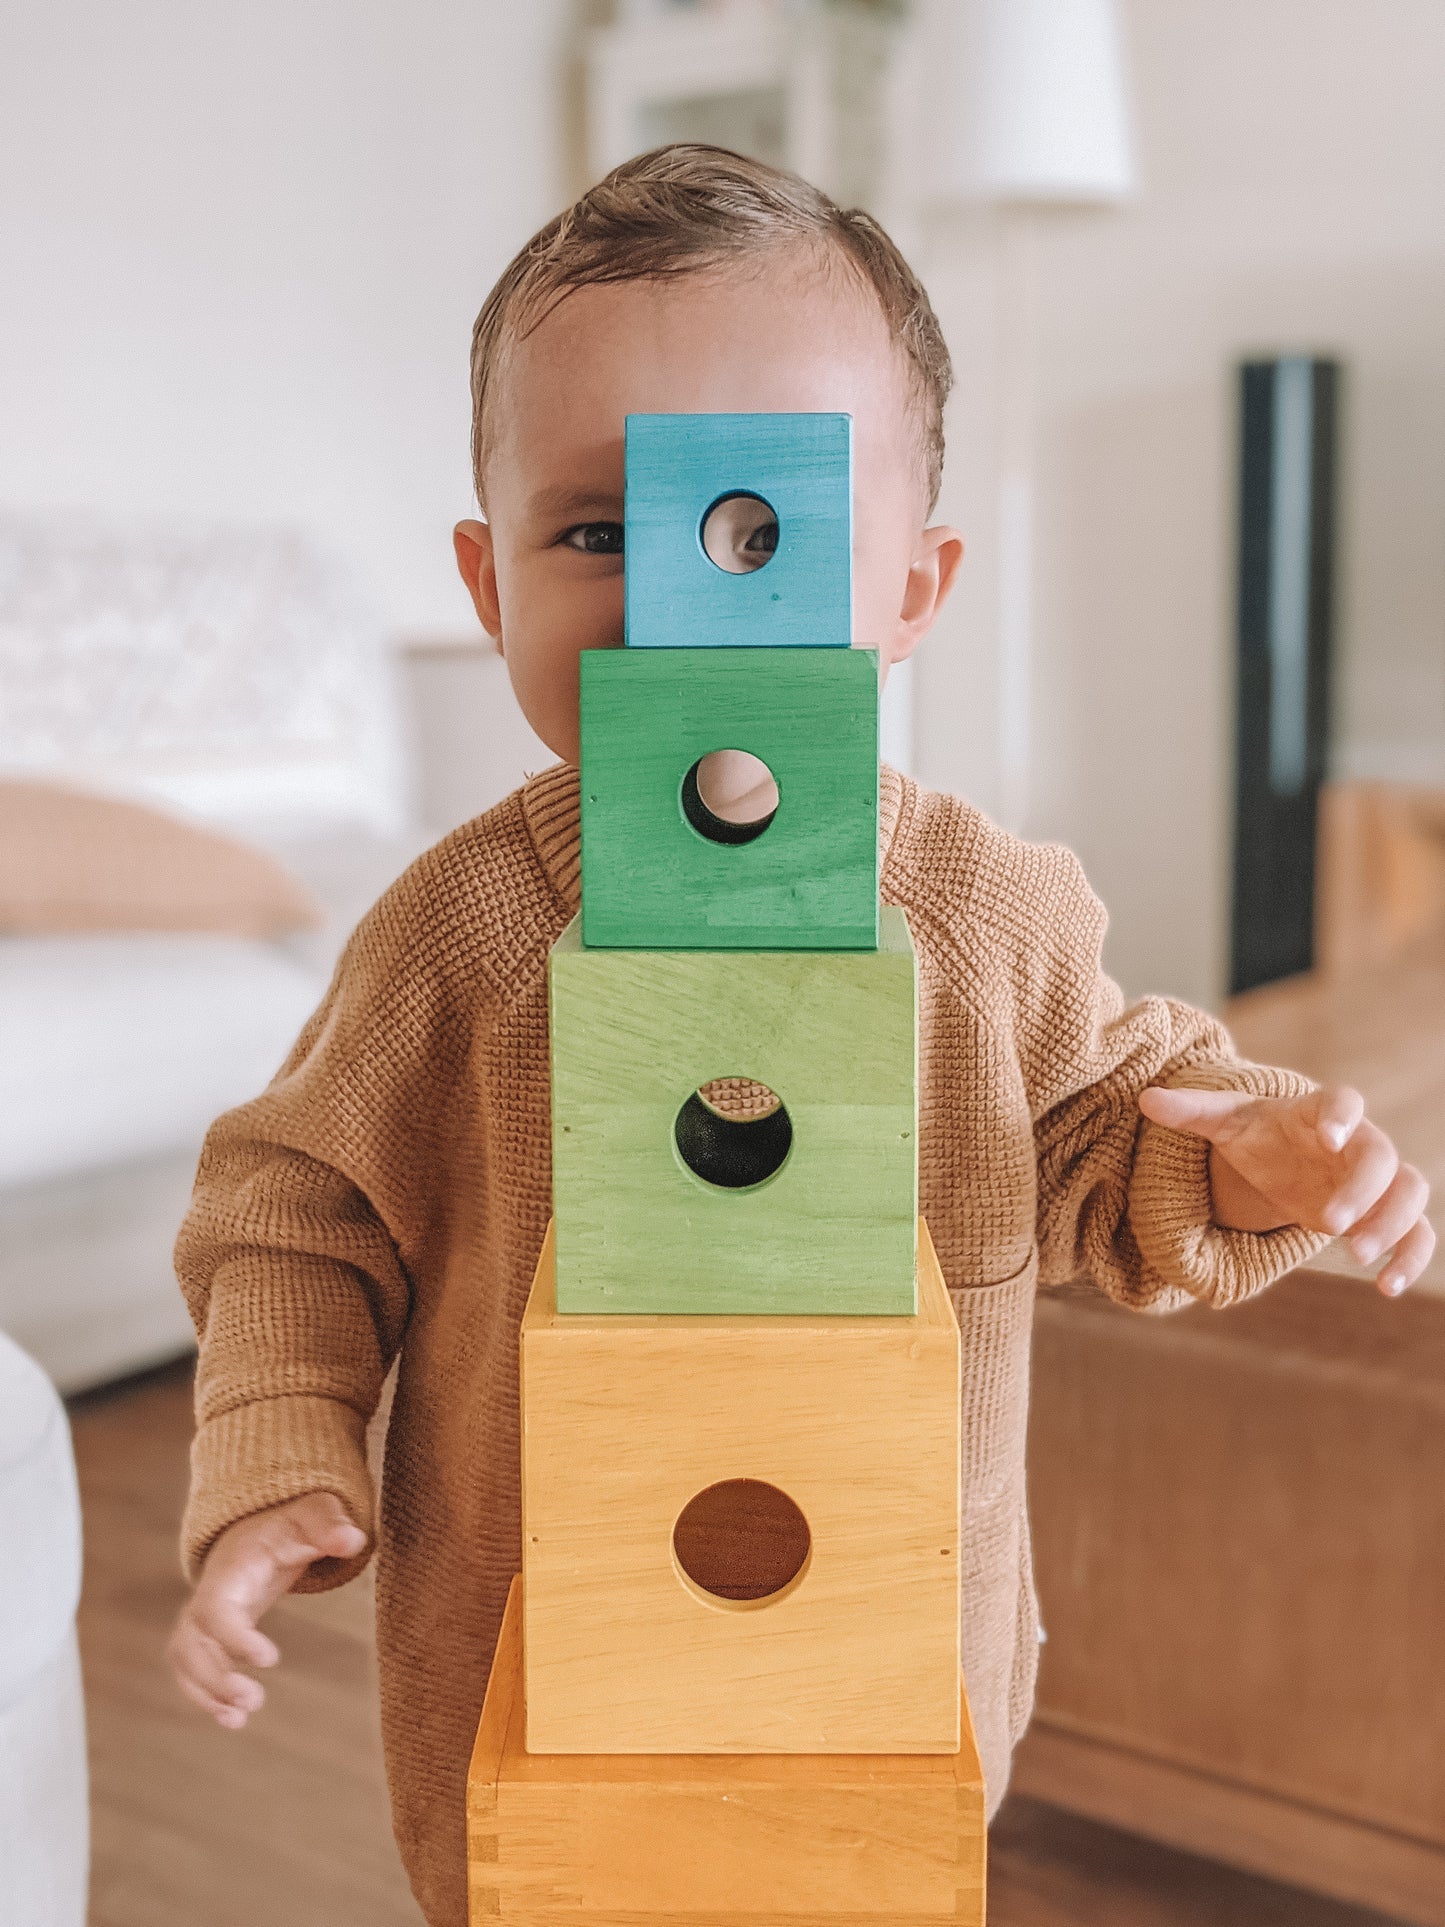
[472,143,954,509]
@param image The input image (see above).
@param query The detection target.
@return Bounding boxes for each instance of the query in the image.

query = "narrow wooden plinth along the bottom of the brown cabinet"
[1010,1721,1445,1927]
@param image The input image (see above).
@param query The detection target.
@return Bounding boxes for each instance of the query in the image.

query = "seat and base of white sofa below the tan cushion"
[0,933,326,1393]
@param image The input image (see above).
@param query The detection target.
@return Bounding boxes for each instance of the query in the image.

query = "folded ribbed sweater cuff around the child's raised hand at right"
[1129,1064,1329,1307]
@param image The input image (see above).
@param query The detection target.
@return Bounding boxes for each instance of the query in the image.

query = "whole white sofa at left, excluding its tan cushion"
[0,515,422,1387]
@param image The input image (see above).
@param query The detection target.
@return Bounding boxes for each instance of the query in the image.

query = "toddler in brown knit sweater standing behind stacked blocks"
[171,146,1432,1927]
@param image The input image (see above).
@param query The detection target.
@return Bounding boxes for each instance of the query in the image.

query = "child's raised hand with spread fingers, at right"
[1139,1085,1435,1297]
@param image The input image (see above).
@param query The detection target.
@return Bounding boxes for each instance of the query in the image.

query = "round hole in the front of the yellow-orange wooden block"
[672,1478,813,1605]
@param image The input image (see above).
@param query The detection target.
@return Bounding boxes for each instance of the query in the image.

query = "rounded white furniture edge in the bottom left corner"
[0,1333,89,1927]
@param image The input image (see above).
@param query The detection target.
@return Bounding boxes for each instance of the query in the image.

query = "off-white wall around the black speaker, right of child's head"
[917,0,1445,998]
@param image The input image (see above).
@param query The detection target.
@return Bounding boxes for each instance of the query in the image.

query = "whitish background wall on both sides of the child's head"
[0,0,1445,998]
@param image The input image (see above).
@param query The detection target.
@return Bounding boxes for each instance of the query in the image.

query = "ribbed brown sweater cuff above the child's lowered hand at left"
[181,1395,376,1592]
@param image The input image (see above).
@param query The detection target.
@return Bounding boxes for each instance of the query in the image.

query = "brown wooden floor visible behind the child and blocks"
[71,1366,1418,1927]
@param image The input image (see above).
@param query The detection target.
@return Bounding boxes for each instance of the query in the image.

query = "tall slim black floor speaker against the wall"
[1229,355,1339,990]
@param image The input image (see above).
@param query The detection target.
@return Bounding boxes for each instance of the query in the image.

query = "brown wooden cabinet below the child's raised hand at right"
[1023,1274,1445,1927]
